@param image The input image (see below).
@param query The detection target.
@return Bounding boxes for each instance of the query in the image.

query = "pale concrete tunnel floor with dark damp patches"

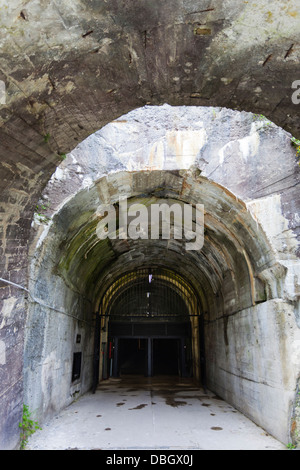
[27,377,286,450]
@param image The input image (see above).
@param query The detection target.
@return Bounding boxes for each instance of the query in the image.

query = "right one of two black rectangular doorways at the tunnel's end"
[153,338,180,375]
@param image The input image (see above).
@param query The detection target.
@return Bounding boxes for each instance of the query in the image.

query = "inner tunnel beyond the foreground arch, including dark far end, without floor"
[24,105,300,442]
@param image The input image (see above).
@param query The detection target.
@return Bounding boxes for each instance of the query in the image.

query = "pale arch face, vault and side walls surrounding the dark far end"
[21,106,300,443]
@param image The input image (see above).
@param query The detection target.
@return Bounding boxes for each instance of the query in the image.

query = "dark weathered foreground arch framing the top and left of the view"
[0,0,300,447]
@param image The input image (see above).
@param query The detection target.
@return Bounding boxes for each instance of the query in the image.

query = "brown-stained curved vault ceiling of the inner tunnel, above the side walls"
[30,171,275,322]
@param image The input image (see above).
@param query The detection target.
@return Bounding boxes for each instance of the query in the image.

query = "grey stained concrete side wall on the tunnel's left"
[23,286,94,423]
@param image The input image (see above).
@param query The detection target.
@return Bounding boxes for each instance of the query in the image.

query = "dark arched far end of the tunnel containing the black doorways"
[95,267,200,386]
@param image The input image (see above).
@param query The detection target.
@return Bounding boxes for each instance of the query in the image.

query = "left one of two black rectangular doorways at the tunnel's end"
[119,338,147,375]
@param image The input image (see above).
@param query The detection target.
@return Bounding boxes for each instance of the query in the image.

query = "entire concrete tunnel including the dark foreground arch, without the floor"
[0,0,300,449]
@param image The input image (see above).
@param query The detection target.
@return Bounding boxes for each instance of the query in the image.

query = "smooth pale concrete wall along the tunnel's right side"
[206,300,300,443]
